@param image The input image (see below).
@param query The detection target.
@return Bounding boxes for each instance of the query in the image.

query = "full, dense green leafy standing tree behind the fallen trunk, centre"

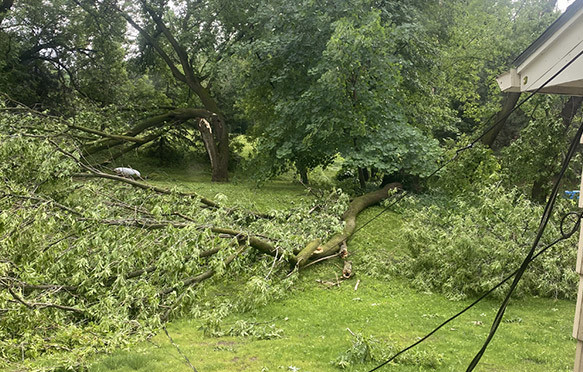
[241,0,436,183]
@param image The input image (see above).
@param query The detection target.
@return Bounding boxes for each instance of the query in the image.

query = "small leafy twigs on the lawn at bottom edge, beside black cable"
[332,333,443,369]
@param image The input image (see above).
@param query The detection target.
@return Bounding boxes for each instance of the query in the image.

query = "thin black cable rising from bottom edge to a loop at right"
[369,212,583,372]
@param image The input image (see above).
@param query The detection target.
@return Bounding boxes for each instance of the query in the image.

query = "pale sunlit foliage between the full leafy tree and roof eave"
[428,0,557,138]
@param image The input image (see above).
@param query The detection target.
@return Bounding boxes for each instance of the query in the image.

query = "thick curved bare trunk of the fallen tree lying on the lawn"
[297,182,402,268]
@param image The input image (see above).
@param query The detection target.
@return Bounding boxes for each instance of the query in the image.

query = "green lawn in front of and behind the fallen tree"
[91,163,575,372]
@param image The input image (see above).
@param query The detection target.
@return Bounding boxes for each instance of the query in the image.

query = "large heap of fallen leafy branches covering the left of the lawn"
[0,109,364,366]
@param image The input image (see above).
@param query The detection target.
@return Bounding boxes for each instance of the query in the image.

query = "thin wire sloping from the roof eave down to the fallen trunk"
[350,50,583,239]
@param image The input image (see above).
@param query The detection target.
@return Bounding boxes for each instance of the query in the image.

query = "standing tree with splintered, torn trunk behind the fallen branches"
[74,0,260,182]
